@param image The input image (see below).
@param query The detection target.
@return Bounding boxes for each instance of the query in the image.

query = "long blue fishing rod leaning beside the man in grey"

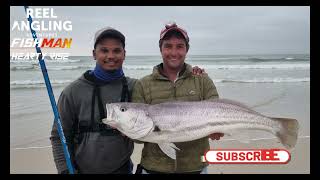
[24,6,74,174]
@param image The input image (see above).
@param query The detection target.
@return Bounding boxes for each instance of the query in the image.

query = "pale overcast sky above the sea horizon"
[10,6,310,55]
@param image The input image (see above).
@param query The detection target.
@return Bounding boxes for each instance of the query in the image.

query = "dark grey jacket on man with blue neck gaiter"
[50,71,136,174]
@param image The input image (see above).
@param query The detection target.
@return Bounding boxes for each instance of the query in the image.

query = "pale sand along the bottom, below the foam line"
[10,136,310,174]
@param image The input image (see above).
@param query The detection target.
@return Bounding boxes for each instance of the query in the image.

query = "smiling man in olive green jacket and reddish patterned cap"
[132,23,223,174]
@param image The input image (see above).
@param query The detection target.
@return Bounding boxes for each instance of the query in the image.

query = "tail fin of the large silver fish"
[271,117,299,149]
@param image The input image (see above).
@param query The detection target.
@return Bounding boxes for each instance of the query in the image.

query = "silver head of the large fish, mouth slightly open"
[102,103,153,139]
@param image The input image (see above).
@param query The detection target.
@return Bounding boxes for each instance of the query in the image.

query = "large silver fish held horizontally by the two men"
[102,99,299,159]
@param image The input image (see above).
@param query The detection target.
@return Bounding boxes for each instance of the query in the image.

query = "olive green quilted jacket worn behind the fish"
[132,63,219,173]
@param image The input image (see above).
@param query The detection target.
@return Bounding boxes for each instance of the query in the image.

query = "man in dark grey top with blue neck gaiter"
[50,28,136,174]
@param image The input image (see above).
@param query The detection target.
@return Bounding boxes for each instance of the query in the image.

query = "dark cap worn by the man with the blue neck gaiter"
[94,28,126,49]
